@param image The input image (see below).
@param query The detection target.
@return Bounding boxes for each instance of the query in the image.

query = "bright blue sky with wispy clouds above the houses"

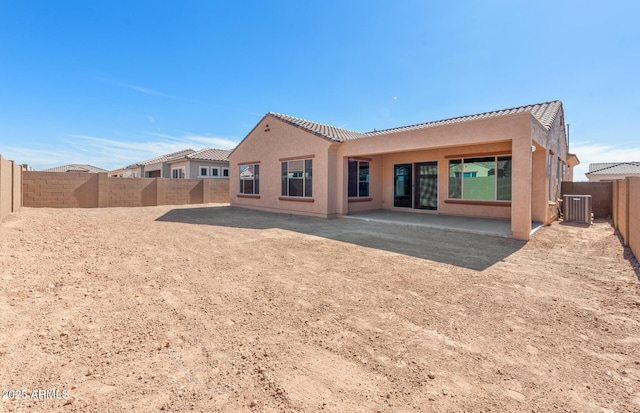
[0,0,640,180]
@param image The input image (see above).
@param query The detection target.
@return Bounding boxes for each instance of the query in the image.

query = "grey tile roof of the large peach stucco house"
[267,100,562,142]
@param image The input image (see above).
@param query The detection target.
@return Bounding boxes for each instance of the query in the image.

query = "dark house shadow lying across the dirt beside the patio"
[156,206,525,271]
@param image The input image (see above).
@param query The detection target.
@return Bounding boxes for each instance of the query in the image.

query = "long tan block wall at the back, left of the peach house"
[22,171,229,208]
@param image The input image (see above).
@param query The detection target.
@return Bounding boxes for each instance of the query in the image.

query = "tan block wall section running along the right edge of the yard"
[612,177,640,259]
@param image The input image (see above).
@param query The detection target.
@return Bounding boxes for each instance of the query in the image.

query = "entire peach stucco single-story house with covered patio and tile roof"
[229,101,578,240]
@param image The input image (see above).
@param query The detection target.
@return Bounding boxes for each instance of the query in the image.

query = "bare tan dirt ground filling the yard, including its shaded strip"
[0,205,640,412]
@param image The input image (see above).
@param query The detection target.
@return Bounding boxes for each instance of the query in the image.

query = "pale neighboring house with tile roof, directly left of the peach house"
[167,148,231,179]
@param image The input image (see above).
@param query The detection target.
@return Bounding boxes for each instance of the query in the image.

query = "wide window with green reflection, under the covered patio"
[449,156,511,201]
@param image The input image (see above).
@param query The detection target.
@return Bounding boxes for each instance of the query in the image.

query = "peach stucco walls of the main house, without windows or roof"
[230,108,567,239]
